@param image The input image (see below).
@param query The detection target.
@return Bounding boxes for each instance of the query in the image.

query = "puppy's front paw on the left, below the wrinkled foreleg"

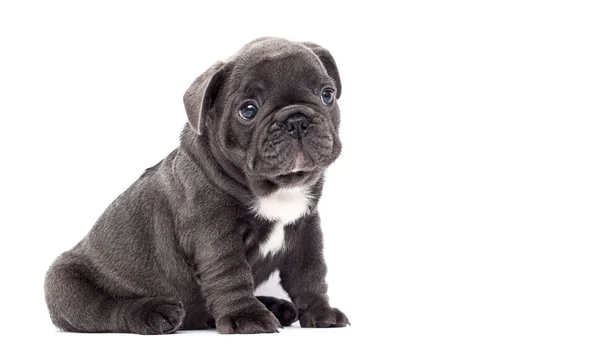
[217,306,281,334]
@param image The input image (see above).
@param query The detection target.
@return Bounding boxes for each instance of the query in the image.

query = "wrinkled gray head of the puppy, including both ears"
[184,38,341,191]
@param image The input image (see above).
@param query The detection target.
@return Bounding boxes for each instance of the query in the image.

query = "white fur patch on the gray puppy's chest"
[253,187,311,257]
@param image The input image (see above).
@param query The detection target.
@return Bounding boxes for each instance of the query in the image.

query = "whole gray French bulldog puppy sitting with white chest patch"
[45,38,348,334]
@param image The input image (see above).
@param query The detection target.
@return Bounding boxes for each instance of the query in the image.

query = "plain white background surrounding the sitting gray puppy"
[0,0,600,362]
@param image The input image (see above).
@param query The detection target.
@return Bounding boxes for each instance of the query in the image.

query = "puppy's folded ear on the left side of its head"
[183,62,226,135]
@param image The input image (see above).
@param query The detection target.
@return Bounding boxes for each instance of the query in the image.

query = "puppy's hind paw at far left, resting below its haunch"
[129,298,185,335]
